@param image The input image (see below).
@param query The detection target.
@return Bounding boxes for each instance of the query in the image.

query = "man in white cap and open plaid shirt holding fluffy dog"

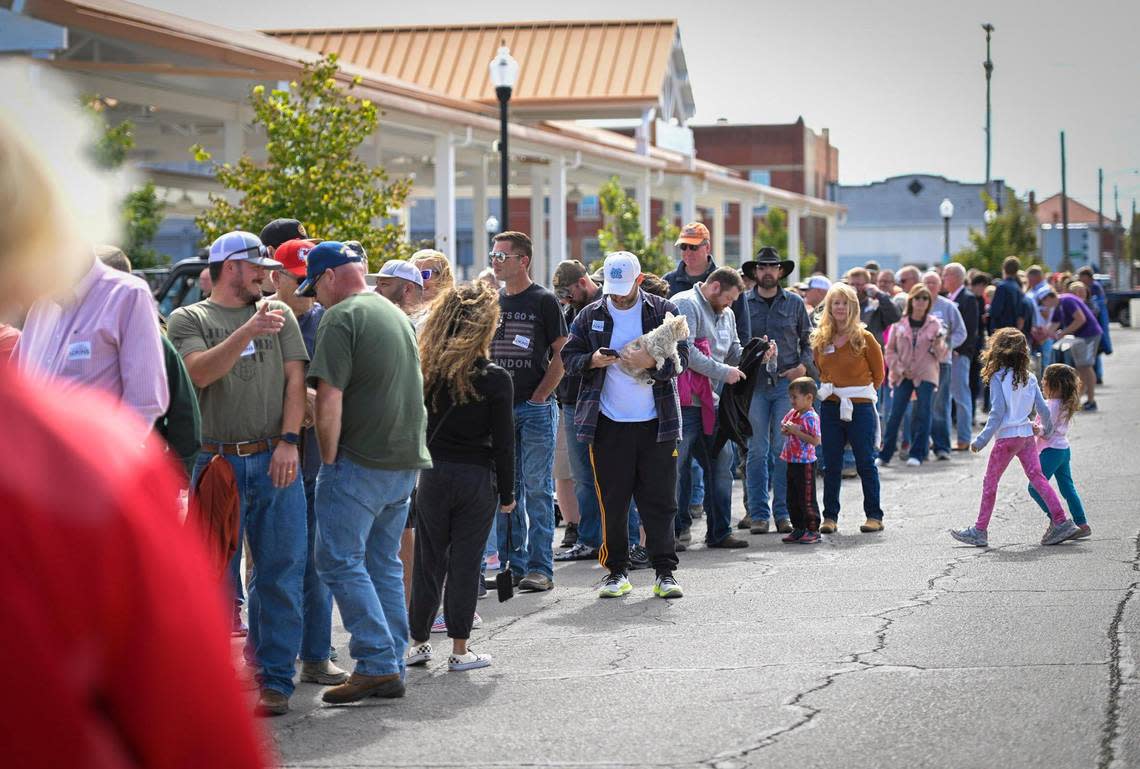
[562,251,689,598]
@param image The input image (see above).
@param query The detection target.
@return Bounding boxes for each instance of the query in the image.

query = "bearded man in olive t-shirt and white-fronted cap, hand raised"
[166,226,309,715]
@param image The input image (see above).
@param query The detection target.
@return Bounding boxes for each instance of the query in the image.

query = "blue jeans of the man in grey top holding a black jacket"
[674,406,734,545]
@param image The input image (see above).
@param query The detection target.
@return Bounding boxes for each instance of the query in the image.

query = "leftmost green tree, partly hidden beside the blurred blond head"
[83,96,170,269]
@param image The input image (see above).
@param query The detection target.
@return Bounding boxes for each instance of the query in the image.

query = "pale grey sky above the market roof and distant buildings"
[142,0,1140,213]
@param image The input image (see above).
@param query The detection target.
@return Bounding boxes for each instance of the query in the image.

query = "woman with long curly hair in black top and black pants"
[407,281,514,670]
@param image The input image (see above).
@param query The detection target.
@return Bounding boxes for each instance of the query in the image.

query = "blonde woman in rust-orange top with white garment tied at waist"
[812,283,884,534]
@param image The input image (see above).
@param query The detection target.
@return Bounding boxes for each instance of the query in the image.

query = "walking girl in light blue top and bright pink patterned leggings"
[950,328,1081,547]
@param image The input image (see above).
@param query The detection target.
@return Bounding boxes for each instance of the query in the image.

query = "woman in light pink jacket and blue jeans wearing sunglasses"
[878,284,946,467]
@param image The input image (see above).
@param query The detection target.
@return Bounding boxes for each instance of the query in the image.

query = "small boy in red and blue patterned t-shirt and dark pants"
[780,376,820,545]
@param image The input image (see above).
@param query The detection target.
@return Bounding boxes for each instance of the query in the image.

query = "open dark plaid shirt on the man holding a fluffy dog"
[562,292,689,443]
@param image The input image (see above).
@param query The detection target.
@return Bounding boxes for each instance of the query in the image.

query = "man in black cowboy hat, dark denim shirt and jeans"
[740,247,814,534]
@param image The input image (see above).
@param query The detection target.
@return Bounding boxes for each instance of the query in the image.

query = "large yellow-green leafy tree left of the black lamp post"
[190,55,412,269]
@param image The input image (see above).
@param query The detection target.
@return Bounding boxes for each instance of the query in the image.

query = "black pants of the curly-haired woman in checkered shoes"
[408,461,498,641]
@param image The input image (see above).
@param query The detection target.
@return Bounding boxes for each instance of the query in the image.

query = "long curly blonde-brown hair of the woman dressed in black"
[420,280,499,403]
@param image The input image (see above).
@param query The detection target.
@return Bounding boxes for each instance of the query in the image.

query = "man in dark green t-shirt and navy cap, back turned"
[296,240,431,704]
